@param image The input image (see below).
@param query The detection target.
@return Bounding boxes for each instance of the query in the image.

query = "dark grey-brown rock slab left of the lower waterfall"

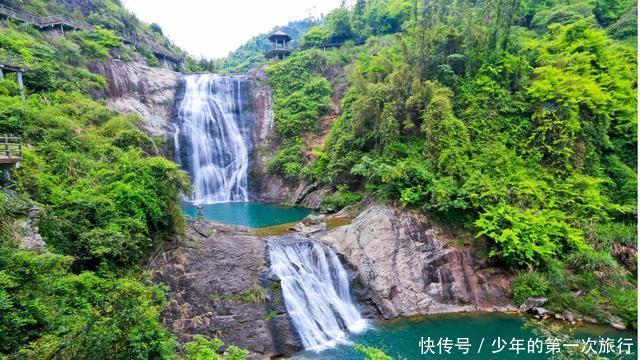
[152,223,300,359]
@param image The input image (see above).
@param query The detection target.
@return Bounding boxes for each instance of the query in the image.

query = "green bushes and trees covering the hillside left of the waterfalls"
[0,0,244,360]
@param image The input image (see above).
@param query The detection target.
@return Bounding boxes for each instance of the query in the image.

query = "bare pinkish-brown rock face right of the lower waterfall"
[319,205,511,319]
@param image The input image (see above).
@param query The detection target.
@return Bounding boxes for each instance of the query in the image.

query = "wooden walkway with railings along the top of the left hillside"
[0,4,184,64]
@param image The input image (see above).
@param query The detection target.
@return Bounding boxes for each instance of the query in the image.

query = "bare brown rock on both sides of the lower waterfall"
[151,204,511,358]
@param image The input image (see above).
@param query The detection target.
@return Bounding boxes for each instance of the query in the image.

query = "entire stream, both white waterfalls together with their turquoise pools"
[174,74,636,360]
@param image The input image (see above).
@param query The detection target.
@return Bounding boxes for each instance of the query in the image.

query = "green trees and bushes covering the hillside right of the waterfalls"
[267,0,637,327]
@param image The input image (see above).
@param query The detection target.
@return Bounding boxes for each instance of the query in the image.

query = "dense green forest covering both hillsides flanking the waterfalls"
[0,0,637,359]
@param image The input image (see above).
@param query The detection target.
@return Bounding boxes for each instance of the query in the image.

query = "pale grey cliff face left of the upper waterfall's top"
[89,60,180,139]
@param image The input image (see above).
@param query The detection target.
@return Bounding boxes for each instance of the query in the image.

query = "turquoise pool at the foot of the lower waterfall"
[297,313,637,360]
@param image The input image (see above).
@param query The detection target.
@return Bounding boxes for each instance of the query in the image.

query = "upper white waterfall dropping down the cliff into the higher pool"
[175,74,253,204]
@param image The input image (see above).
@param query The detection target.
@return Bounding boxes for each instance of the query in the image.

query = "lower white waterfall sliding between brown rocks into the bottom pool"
[269,241,367,351]
